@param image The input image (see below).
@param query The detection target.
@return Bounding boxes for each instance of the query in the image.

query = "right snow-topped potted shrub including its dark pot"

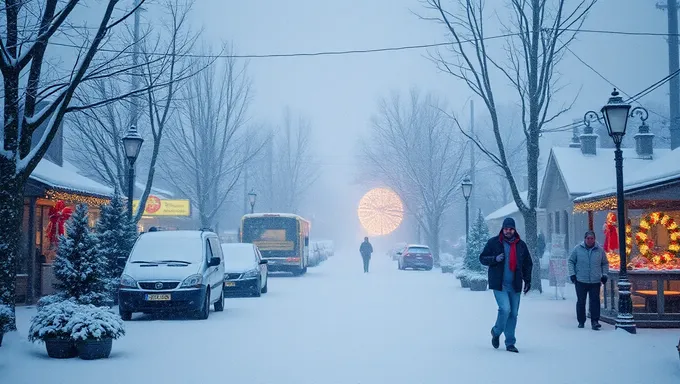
[67,305,125,360]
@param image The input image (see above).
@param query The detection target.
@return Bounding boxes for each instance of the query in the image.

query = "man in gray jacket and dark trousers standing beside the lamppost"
[568,231,609,331]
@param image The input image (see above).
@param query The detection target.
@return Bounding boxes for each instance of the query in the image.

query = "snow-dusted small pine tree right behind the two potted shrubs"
[54,204,110,306]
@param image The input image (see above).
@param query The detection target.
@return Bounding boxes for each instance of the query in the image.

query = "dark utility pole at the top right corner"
[656,0,680,149]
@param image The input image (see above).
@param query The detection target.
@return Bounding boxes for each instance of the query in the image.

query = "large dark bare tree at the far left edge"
[0,0,144,328]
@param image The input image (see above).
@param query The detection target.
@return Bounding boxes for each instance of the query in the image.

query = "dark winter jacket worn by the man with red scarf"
[479,230,534,293]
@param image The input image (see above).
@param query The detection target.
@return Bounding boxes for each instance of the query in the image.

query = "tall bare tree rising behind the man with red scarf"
[424,0,596,292]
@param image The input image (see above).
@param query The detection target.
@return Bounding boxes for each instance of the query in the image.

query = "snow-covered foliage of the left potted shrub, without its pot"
[28,300,82,342]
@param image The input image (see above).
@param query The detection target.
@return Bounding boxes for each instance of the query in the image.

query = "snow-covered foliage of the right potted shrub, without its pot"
[66,305,125,341]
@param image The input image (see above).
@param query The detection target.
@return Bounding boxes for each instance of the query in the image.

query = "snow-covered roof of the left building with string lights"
[30,159,113,197]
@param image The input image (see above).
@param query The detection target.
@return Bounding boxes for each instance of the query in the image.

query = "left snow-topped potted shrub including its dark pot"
[28,300,82,359]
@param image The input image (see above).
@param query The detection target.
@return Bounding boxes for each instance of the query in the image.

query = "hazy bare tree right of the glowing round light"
[362,90,465,262]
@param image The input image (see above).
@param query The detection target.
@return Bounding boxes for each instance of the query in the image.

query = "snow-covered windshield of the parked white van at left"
[129,236,203,263]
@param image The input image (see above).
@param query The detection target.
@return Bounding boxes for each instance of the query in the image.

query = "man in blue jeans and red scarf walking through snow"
[479,217,533,353]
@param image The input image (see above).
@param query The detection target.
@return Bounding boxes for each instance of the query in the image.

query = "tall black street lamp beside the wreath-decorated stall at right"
[583,88,647,333]
